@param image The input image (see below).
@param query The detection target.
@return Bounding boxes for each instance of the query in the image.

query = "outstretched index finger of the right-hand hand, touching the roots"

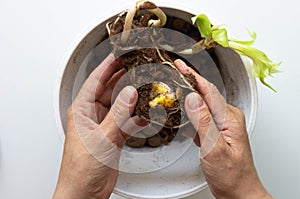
[174,59,226,129]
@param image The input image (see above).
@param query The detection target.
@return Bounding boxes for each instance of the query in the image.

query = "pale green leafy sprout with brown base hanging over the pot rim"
[192,14,281,92]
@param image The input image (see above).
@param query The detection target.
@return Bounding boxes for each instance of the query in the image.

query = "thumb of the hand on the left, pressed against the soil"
[100,86,138,146]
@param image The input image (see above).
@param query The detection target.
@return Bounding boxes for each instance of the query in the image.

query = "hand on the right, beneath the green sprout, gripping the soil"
[175,60,272,199]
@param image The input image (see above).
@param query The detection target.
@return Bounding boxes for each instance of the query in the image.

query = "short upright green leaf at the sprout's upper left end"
[192,14,212,38]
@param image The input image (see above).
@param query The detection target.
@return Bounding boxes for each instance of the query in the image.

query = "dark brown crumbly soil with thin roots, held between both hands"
[109,6,200,147]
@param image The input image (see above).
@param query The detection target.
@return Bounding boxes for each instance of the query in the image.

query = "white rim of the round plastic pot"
[53,2,258,199]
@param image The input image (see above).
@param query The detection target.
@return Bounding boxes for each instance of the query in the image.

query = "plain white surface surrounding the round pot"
[0,0,300,199]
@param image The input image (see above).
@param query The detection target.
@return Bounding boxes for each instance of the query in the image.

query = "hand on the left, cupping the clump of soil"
[54,54,144,199]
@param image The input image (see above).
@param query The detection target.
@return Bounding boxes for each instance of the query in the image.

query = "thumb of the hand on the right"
[185,93,220,157]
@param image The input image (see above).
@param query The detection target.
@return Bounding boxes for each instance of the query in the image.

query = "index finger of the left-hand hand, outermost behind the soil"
[78,54,118,103]
